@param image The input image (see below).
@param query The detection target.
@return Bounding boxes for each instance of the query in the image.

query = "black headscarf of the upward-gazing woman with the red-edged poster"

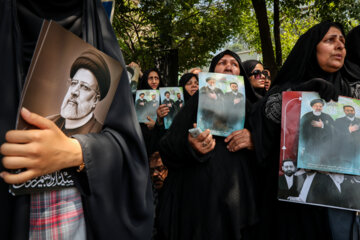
[269,21,348,95]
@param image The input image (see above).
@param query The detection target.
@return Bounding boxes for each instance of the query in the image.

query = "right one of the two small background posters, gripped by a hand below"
[159,87,184,129]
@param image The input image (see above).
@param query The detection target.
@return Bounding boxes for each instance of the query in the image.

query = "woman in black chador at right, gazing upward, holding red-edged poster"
[250,22,351,239]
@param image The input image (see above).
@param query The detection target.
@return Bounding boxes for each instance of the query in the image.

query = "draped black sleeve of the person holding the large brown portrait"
[74,129,153,239]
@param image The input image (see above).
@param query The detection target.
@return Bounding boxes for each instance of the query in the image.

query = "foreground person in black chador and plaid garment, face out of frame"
[0,0,154,240]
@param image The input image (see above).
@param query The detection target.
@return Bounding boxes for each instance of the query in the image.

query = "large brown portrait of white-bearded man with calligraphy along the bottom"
[10,21,123,195]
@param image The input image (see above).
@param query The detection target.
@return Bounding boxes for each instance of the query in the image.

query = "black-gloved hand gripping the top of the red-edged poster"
[292,78,339,102]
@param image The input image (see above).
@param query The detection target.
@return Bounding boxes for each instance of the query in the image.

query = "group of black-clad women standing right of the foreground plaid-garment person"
[133,22,360,239]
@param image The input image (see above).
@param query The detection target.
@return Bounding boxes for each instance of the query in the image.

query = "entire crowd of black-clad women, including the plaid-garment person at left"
[0,3,360,240]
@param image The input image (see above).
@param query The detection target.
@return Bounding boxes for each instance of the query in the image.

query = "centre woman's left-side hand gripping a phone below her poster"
[188,123,216,154]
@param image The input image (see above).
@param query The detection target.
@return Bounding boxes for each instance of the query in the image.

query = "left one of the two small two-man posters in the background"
[135,90,160,123]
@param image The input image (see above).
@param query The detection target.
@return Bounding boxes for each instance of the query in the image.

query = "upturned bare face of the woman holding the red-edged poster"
[316,27,346,73]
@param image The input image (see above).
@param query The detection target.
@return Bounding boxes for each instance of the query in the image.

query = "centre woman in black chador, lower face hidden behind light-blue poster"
[159,50,257,239]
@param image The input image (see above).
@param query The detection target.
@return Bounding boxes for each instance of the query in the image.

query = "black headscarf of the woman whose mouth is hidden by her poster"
[209,50,259,103]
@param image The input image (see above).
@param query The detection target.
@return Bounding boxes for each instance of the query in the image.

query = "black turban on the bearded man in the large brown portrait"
[70,50,110,100]
